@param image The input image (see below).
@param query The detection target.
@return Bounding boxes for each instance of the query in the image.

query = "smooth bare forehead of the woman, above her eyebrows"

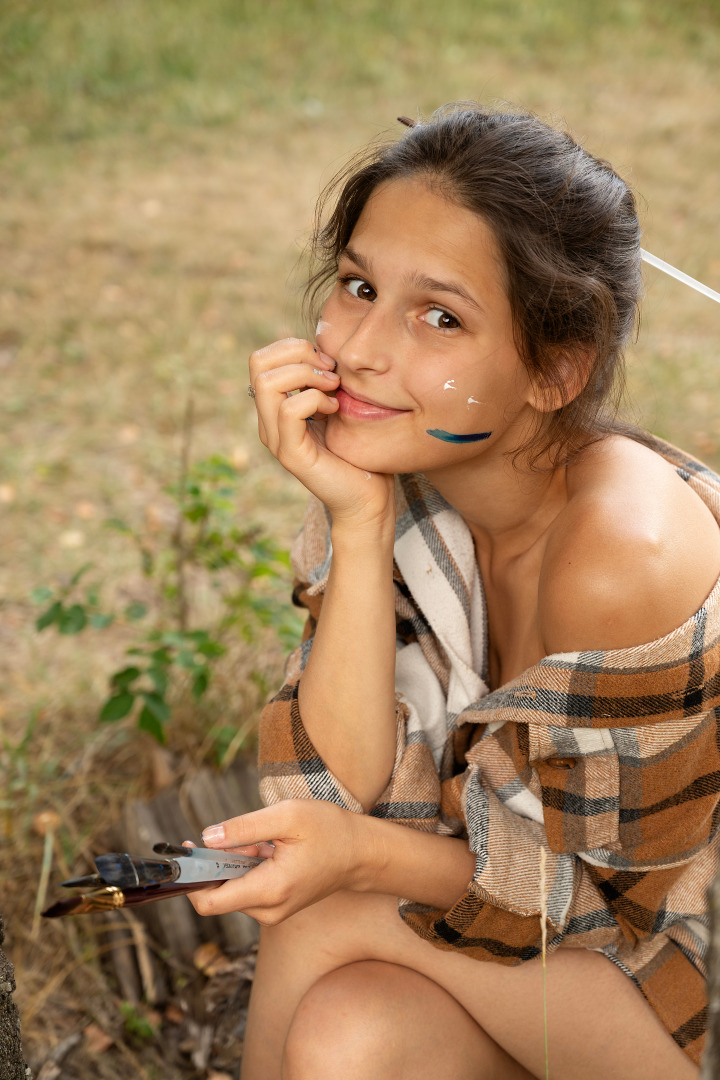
[350,177,505,293]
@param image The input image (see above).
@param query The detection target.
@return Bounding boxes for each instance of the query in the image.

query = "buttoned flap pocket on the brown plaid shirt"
[530,728,620,852]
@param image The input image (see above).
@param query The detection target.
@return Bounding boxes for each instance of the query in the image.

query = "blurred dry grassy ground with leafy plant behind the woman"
[0,0,720,1080]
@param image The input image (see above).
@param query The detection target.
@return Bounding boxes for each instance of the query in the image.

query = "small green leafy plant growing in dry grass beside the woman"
[32,408,301,743]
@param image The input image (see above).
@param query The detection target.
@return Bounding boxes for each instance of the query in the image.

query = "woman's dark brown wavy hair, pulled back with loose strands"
[305,103,642,464]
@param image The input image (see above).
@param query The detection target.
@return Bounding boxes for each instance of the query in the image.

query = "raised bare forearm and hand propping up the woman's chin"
[250,339,396,809]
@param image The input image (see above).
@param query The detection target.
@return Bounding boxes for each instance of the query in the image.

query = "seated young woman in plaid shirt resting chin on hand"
[188,105,720,1080]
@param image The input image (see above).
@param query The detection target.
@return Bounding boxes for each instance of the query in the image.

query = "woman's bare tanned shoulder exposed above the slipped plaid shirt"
[539,436,720,654]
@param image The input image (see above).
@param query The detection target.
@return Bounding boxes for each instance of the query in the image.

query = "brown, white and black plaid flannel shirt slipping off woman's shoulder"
[259,441,720,1062]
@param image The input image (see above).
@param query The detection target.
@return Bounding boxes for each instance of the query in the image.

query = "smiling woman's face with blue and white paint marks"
[316,178,538,475]
